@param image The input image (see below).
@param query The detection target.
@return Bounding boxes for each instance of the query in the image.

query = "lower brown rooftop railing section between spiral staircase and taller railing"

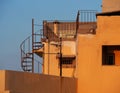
[44,21,76,41]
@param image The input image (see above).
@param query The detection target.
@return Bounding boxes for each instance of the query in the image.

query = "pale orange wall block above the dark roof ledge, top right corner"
[102,0,120,12]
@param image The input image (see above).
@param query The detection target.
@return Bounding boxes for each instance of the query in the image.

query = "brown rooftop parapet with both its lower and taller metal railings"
[43,10,96,41]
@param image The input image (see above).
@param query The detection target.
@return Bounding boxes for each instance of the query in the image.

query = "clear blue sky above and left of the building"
[0,0,102,70]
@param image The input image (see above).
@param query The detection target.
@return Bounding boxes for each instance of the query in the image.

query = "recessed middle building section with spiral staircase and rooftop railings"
[21,10,96,77]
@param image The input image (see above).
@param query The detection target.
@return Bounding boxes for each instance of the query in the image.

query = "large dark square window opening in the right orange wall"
[102,45,120,65]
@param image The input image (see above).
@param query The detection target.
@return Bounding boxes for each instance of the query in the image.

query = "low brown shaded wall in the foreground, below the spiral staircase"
[0,71,77,93]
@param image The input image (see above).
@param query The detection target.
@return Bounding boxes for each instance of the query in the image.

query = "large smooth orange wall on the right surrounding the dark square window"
[77,16,120,93]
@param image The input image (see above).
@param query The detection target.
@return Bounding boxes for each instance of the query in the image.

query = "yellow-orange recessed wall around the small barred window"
[43,41,76,77]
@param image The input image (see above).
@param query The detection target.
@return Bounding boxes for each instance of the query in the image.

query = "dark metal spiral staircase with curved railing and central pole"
[20,19,43,73]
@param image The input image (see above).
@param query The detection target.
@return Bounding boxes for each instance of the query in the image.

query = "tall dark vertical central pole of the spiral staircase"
[32,19,34,73]
